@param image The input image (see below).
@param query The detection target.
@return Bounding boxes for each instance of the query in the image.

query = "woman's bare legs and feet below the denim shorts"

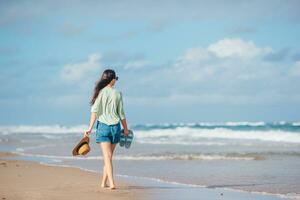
[101,142,116,189]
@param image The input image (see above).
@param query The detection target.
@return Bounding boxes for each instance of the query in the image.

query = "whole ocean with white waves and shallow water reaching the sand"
[0,122,300,199]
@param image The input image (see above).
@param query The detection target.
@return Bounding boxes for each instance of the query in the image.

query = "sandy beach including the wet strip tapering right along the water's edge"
[0,152,290,200]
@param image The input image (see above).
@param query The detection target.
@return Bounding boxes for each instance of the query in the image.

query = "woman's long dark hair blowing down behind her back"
[90,69,116,105]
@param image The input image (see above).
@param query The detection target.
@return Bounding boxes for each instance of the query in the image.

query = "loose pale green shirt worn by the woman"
[91,86,125,125]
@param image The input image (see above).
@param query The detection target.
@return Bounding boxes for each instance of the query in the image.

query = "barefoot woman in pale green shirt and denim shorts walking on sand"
[84,69,128,189]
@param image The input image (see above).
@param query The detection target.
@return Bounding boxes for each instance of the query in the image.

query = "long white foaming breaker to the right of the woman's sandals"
[135,127,300,144]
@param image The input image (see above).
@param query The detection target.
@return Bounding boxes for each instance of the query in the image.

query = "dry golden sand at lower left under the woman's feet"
[0,153,141,200]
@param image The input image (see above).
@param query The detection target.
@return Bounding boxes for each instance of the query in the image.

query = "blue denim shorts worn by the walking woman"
[96,120,121,144]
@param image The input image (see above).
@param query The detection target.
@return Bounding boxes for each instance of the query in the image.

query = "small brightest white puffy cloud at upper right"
[207,38,272,58]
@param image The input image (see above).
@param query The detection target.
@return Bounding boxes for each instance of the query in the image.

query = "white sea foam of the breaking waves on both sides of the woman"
[0,122,300,145]
